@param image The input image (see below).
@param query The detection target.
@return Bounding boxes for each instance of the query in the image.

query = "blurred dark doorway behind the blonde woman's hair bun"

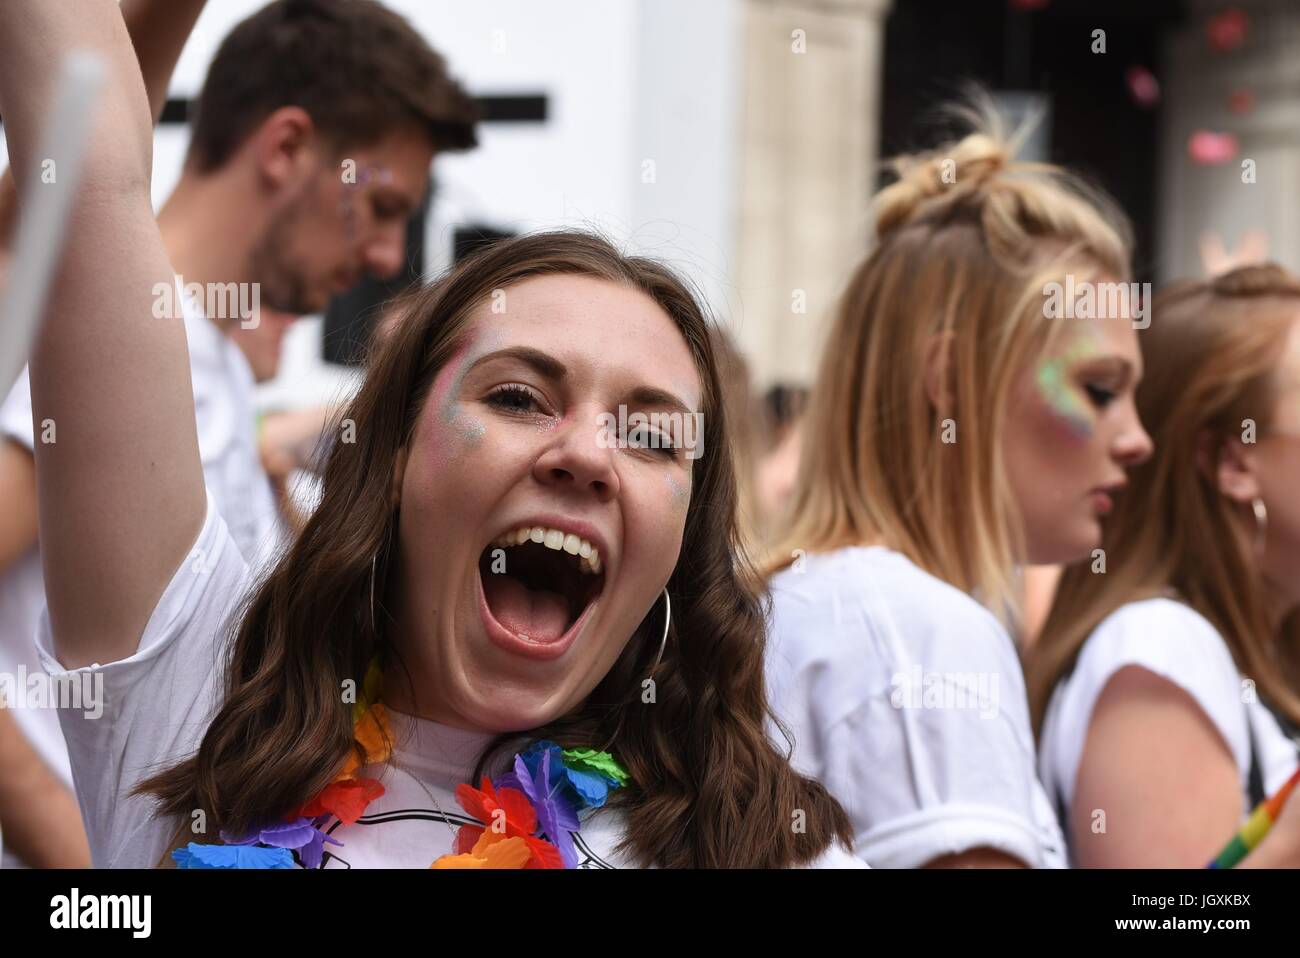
[880,0,1186,281]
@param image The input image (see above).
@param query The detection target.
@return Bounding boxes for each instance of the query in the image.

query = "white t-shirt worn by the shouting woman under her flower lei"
[38,497,861,868]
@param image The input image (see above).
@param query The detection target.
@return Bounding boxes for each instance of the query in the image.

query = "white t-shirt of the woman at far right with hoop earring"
[1039,598,1297,857]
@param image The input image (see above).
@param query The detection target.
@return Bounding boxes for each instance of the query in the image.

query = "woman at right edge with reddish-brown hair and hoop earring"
[1027,265,1300,868]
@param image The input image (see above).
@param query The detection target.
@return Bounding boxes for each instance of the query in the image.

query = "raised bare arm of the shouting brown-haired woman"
[0,0,204,667]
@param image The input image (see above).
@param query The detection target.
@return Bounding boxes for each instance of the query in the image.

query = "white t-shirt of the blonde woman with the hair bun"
[767,546,1065,868]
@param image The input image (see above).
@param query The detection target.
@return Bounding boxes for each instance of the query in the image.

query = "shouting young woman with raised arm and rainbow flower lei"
[0,0,854,867]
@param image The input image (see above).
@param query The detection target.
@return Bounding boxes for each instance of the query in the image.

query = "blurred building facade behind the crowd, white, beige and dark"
[5,0,1300,395]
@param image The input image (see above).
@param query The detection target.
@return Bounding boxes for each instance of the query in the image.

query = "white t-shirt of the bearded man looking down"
[0,283,281,867]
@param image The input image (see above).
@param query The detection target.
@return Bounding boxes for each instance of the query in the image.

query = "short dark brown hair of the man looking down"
[187,0,478,173]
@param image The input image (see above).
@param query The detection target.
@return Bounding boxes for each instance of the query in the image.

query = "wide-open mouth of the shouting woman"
[478,526,605,659]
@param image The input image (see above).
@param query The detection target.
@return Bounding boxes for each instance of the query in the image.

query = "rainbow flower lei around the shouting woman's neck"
[172,663,629,868]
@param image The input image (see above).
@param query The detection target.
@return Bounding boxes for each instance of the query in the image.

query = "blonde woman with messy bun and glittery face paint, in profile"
[767,103,1151,867]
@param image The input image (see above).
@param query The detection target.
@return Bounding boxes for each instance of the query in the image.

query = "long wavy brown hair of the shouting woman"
[139,231,852,867]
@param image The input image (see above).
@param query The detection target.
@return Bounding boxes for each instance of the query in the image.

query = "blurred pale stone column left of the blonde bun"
[732,0,891,387]
